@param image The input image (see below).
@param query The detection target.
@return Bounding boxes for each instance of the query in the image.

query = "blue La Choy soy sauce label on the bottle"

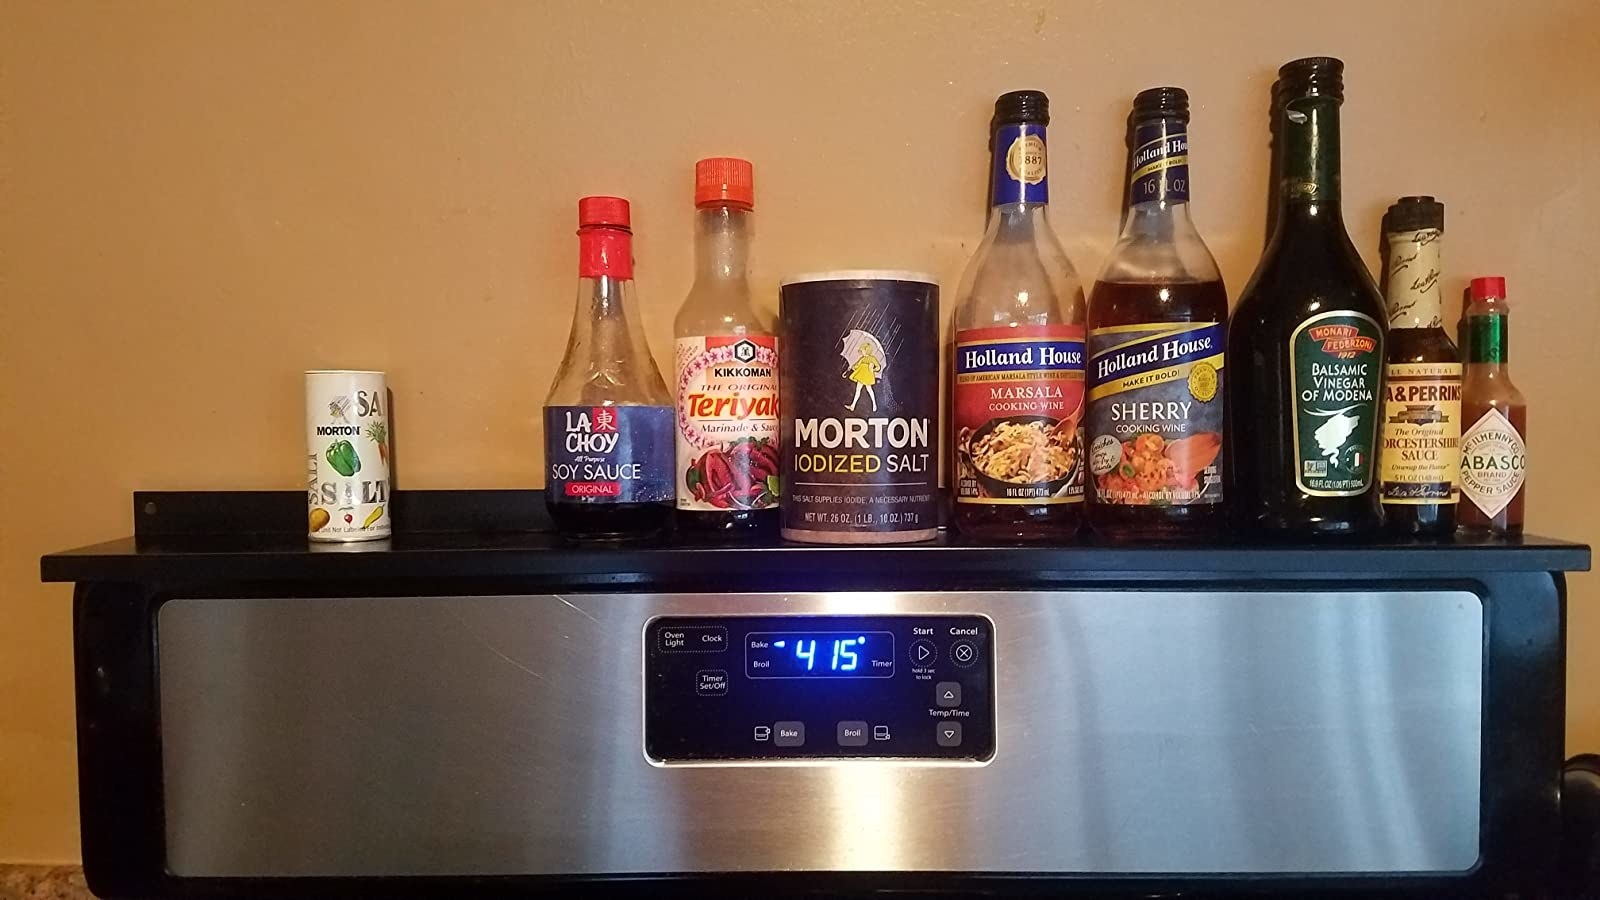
[544,407,674,503]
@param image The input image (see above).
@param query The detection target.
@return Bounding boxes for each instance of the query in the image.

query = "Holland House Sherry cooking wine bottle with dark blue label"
[1085,88,1227,538]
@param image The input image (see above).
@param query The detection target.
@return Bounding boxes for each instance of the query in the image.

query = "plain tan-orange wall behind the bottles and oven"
[0,0,1600,862]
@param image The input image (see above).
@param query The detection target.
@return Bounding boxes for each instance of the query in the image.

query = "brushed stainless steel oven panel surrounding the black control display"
[157,591,1483,876]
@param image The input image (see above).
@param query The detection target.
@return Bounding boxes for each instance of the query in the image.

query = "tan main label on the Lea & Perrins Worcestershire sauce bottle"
[1378,362,1461,506]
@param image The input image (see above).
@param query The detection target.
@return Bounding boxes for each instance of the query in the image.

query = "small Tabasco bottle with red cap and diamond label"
[1459,277,1528,536]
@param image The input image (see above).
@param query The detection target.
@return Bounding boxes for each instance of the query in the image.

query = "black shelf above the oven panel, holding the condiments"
[40,490,1590,589]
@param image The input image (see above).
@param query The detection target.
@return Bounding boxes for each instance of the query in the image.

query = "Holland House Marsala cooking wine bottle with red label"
[950,91,1083,541]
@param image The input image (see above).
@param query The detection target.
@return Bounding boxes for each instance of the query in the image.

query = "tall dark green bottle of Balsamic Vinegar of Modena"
[1226,56,1387,536]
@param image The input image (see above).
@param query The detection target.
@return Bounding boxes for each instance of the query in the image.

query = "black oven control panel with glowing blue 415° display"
[645,615,995,762]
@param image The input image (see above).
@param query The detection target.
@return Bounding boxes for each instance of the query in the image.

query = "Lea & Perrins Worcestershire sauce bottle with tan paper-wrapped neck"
[1378,197,1461,536]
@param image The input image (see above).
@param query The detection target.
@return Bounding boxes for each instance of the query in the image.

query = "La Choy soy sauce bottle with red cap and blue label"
[544,197,675,540]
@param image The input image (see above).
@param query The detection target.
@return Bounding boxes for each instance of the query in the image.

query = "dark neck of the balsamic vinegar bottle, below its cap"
[1278,96,1344,229]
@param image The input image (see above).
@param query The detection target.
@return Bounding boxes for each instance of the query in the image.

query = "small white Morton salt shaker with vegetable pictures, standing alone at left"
[306,370,389,541]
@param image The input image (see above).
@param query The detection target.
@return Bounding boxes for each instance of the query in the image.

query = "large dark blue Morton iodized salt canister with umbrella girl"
[778,271,939,544]
